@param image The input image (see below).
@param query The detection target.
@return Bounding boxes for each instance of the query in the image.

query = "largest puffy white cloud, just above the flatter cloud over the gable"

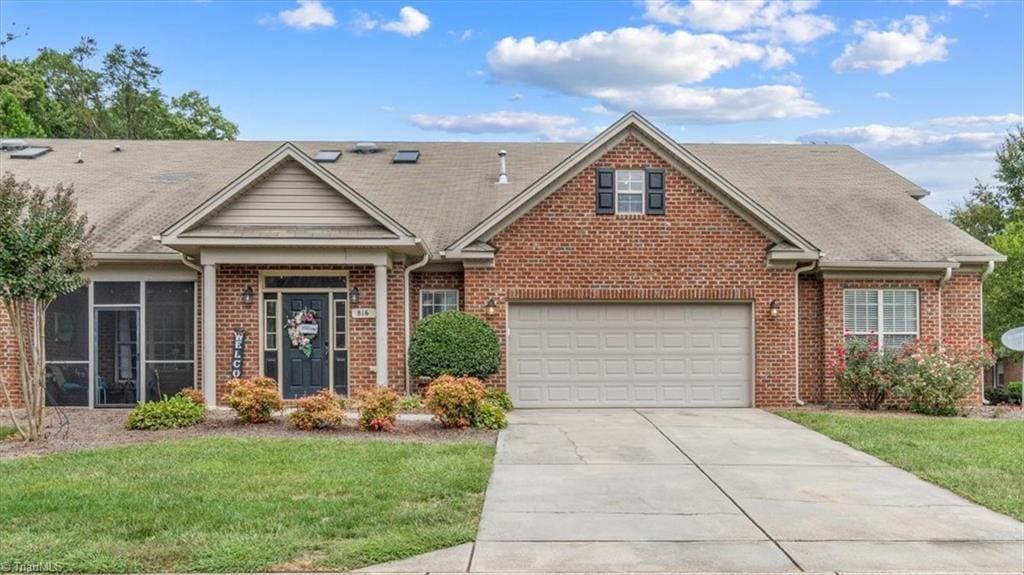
[487,27,766,93]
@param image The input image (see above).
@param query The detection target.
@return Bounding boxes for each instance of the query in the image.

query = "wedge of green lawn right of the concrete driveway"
[778,411,1024,521]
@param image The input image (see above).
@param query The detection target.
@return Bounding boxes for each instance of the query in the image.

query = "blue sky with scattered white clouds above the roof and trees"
[0,0,1024,212]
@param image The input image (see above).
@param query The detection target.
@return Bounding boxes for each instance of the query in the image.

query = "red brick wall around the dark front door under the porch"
[209,264,406,403]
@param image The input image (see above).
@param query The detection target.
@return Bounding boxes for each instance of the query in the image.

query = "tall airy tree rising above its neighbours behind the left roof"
[103,44,164,139]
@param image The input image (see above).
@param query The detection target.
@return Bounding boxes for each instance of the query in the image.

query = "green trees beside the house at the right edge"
[949,126,1024,356]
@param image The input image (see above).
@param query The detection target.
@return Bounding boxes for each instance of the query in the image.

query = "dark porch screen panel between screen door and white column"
[145,281,196,401]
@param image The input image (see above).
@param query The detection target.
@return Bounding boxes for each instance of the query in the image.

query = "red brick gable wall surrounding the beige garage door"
[465,136,796,406]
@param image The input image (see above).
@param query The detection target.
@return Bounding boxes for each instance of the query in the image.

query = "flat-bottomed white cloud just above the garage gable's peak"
[593,85,828,124]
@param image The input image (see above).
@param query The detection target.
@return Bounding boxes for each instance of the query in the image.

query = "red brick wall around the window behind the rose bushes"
[819,273,982,405]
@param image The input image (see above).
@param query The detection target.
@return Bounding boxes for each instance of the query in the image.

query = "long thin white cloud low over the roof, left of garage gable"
[409,110,600,140]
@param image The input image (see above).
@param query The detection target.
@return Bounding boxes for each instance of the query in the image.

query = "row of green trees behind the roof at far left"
[0,33,239,140]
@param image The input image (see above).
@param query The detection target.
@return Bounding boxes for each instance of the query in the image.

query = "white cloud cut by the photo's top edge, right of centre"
[644,0,836,44]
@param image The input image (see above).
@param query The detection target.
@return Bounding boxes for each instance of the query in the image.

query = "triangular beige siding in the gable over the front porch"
[204,161,383,229]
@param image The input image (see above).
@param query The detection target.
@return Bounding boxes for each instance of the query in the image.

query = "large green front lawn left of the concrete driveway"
[0,438,494,572]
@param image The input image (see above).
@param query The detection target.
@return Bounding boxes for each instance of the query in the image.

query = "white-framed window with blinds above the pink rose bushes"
[843,290,918,349]
